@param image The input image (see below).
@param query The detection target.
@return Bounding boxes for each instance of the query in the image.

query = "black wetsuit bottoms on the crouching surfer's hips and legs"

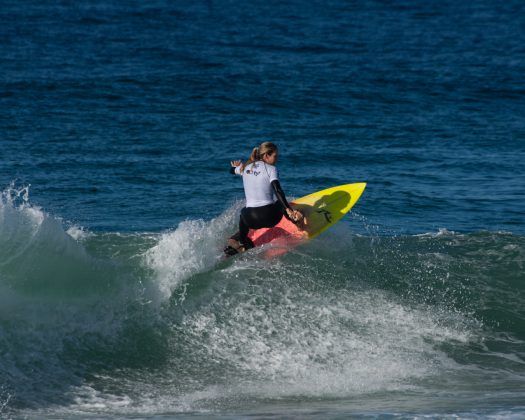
[236,201,284,249]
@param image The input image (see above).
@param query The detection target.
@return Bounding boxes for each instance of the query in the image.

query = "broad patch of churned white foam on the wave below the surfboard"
[177,278,468,398]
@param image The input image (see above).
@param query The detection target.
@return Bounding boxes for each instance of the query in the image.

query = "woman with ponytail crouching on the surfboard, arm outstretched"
[224,142,303,255]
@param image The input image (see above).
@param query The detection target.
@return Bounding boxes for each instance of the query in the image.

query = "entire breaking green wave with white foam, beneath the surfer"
[0,187,525,417]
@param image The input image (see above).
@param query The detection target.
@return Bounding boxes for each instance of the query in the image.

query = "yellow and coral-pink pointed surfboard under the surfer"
[248,182,366,246]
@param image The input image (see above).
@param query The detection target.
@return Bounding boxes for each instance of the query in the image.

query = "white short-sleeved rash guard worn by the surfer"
[235,160,279,207]
